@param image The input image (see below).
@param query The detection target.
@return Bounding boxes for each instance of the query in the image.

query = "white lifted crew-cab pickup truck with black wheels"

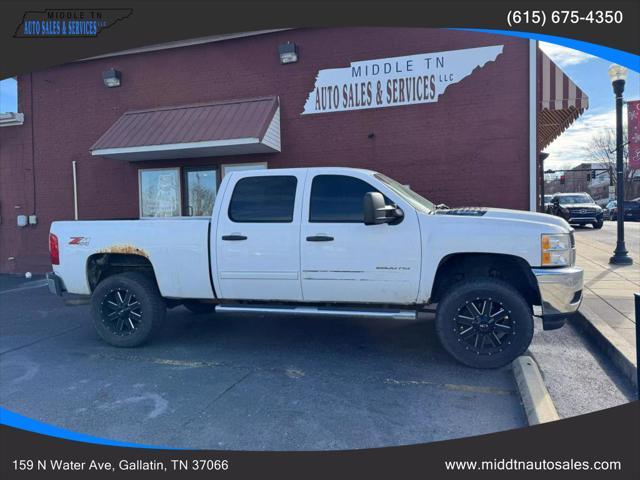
[48,168,583,368]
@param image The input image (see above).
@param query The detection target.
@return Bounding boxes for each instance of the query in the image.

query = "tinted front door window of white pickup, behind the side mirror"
[309,175,390,223]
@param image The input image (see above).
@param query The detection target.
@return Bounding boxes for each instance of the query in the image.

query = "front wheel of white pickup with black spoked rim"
[436,278,533,368]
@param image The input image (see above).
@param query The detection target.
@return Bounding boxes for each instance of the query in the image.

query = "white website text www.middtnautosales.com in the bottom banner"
[444,458,622,471]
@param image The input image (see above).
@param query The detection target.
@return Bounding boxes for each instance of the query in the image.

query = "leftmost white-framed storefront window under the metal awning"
[139,168,180,217]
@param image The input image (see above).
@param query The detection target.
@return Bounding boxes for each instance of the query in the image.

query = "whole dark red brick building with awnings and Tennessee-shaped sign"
[0,28,587,272]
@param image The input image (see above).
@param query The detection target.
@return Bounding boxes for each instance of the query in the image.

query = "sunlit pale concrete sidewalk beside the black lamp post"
[576,232,640,353]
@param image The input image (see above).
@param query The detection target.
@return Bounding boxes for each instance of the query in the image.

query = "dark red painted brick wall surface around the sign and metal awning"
[0,28,529,272]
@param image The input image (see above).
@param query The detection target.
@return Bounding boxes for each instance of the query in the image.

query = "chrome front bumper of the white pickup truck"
[533,267,584,330]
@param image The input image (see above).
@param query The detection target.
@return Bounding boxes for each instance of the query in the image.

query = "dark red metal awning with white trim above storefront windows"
[90,97,280,161]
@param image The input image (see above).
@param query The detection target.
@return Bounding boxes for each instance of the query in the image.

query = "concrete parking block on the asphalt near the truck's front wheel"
[511,355,560,425]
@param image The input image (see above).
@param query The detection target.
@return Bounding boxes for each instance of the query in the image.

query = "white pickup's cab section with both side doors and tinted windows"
[211,169,422,304]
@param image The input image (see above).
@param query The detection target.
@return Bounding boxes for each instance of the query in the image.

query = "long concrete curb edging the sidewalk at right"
[572,311,638,389]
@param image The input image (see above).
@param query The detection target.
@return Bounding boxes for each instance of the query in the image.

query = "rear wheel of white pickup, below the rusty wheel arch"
[91,272,166,347]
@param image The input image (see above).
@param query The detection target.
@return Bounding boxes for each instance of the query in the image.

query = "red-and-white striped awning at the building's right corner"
[537,49,589,150]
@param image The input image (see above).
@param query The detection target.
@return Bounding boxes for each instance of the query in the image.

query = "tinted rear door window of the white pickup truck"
[229,175,298,223]
